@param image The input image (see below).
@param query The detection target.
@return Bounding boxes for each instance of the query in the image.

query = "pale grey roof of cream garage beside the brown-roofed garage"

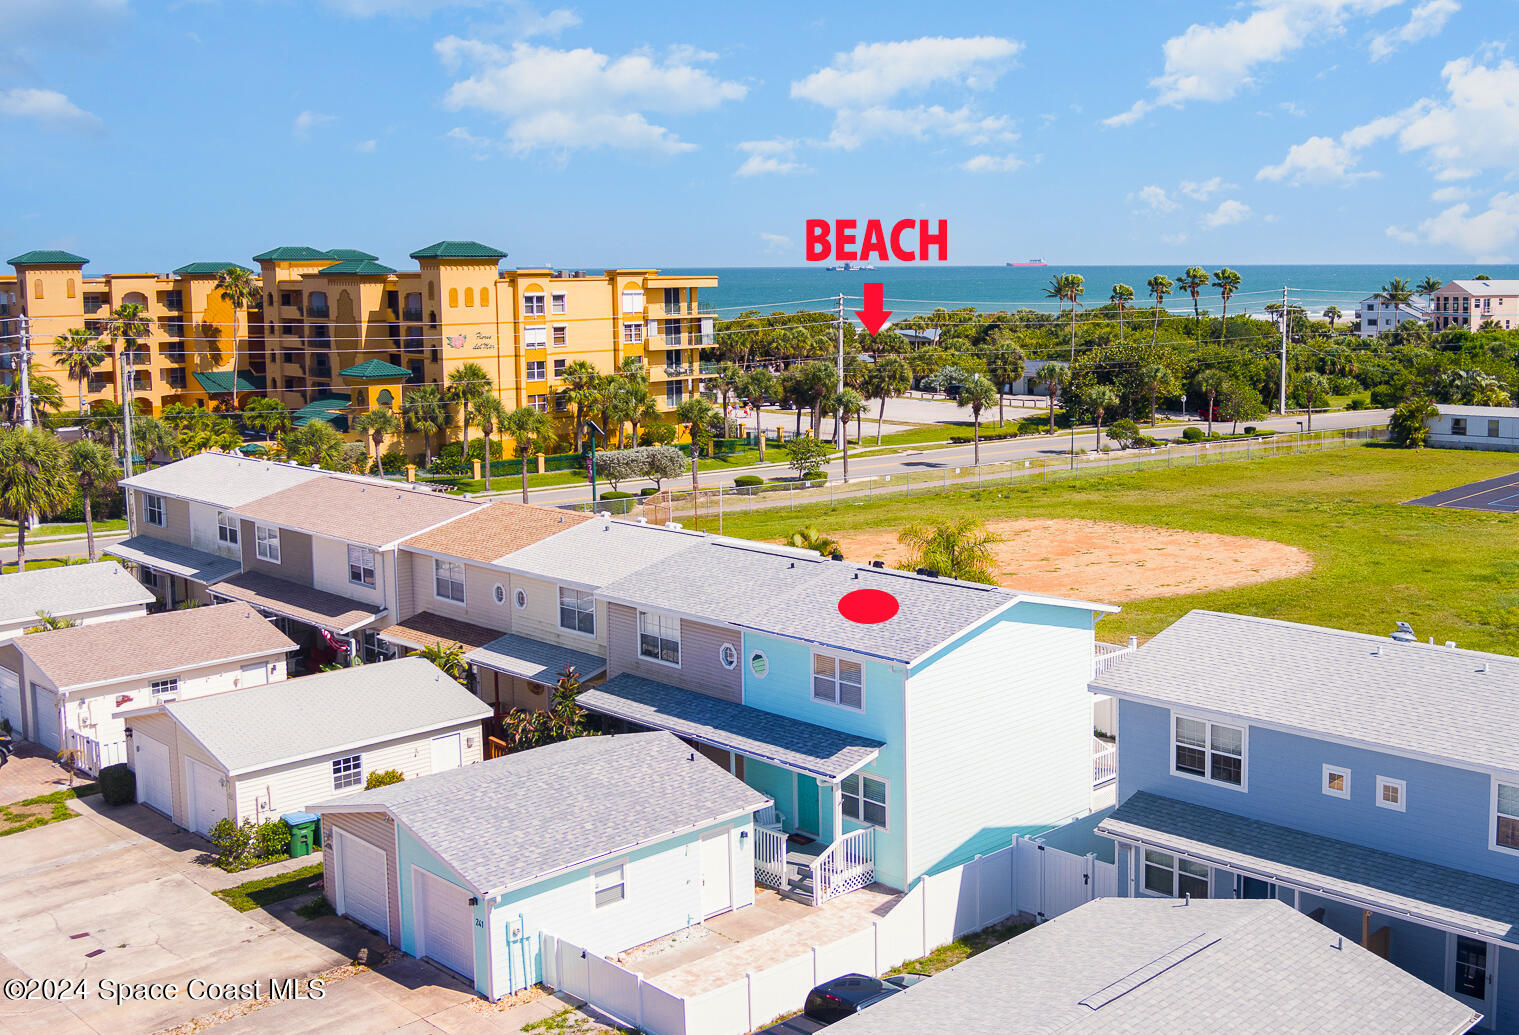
[164,658,491,774]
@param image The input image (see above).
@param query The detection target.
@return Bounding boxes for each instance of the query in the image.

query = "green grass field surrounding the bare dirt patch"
[723,447,1519,654]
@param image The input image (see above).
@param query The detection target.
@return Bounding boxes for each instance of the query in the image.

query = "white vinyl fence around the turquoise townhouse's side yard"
[542,836,1118,1035]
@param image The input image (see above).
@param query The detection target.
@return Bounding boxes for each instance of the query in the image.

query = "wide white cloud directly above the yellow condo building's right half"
[434,36,747,155]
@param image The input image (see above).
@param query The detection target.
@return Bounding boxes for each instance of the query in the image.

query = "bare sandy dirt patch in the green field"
[837,518,1314,603]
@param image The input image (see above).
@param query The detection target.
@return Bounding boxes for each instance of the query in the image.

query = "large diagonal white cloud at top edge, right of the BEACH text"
[1103,0,1399,126]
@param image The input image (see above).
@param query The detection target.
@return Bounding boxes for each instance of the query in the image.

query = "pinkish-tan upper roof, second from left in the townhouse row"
[237,476,485,549]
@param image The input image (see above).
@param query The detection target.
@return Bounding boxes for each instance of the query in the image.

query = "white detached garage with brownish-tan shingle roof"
[15,603,295,774]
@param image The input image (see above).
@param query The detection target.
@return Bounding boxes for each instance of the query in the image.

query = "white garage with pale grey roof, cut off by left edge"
[0,561,153,736]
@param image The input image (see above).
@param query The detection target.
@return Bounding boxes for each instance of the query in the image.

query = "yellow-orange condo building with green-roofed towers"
[0,240,717,446]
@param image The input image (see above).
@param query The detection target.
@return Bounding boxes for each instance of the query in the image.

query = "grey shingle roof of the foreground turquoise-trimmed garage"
[310,729,766,895]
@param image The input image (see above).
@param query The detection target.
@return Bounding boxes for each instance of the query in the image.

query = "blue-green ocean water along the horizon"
[664,263,1519,319]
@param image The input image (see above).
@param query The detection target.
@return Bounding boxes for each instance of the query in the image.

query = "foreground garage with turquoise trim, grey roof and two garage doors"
[310,729,769,1000]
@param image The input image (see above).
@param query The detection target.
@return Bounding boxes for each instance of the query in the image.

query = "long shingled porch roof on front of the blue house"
[1097,790,1519,942]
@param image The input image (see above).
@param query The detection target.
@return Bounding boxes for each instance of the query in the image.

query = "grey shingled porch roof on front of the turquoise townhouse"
[576,673,886,781]
